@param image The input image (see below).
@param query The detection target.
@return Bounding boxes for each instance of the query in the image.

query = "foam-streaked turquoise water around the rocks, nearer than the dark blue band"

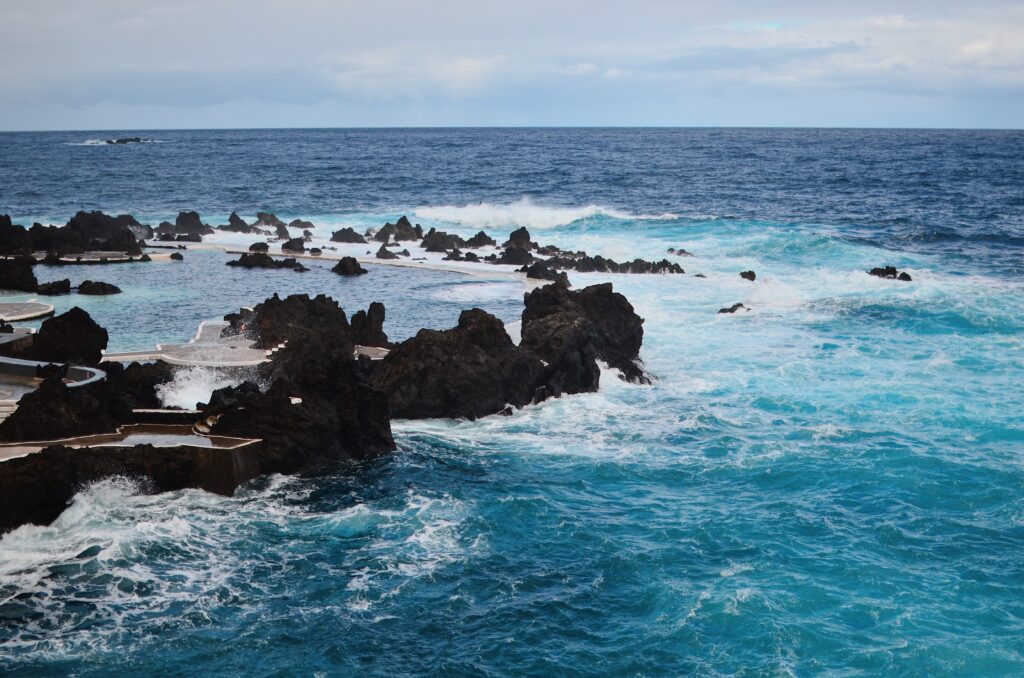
[0,130,1024,676]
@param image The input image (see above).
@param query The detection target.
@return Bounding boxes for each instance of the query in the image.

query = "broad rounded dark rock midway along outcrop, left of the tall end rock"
[370,308,545,419]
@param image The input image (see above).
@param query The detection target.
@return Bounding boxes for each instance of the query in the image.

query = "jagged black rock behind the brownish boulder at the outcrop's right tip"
[522,283,650,383]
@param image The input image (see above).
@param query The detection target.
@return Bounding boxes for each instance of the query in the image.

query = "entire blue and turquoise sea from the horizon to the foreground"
[0,129,1024,676]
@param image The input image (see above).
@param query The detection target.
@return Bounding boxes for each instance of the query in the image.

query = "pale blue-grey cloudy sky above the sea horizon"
[0,0,1024,131]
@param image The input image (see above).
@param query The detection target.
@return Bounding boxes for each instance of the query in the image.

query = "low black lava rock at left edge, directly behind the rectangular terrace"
[0,375,127,442]
